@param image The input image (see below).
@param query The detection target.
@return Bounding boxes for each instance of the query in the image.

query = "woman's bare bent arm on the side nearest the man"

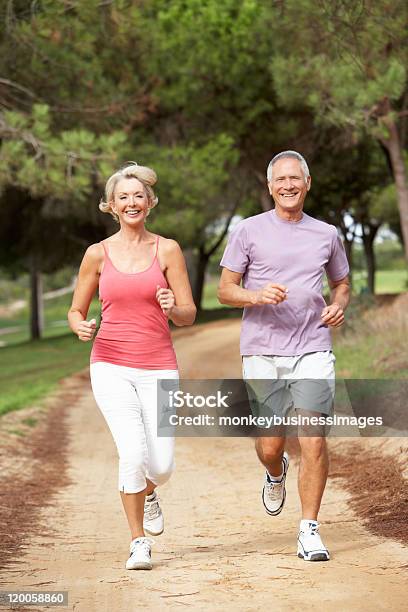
[156,240,197,327]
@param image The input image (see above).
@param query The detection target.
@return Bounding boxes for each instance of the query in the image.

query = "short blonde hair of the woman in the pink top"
[99,161,159,221]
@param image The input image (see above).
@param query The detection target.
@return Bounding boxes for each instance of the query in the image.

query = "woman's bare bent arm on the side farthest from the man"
[68,244,103,342]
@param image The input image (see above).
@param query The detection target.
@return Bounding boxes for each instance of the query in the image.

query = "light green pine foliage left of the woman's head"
[0,104,126,205]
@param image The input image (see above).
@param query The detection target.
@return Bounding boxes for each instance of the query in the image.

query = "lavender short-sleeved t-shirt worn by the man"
[220,210,349,355]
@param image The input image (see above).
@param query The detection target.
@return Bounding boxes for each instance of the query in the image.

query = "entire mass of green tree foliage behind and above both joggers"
[0,0,407,304]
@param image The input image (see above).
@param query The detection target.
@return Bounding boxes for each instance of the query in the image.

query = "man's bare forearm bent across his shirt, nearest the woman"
[217,268,287,308]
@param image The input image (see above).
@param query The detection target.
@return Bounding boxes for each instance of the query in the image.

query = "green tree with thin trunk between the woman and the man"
[137,134,241,308]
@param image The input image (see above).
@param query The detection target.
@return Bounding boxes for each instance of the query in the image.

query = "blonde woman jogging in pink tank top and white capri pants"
[68,162,196,569]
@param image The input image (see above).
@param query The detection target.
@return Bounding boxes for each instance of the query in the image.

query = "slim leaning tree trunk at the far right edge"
[382,108,408,262]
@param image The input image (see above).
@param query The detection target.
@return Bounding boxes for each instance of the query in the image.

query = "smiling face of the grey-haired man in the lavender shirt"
[268,157,310,213]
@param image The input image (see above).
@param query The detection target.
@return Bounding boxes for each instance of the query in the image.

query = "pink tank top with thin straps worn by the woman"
[91,237,177,370]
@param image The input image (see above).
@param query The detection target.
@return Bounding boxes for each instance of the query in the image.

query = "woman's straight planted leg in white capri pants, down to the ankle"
[91,362,147,539]
